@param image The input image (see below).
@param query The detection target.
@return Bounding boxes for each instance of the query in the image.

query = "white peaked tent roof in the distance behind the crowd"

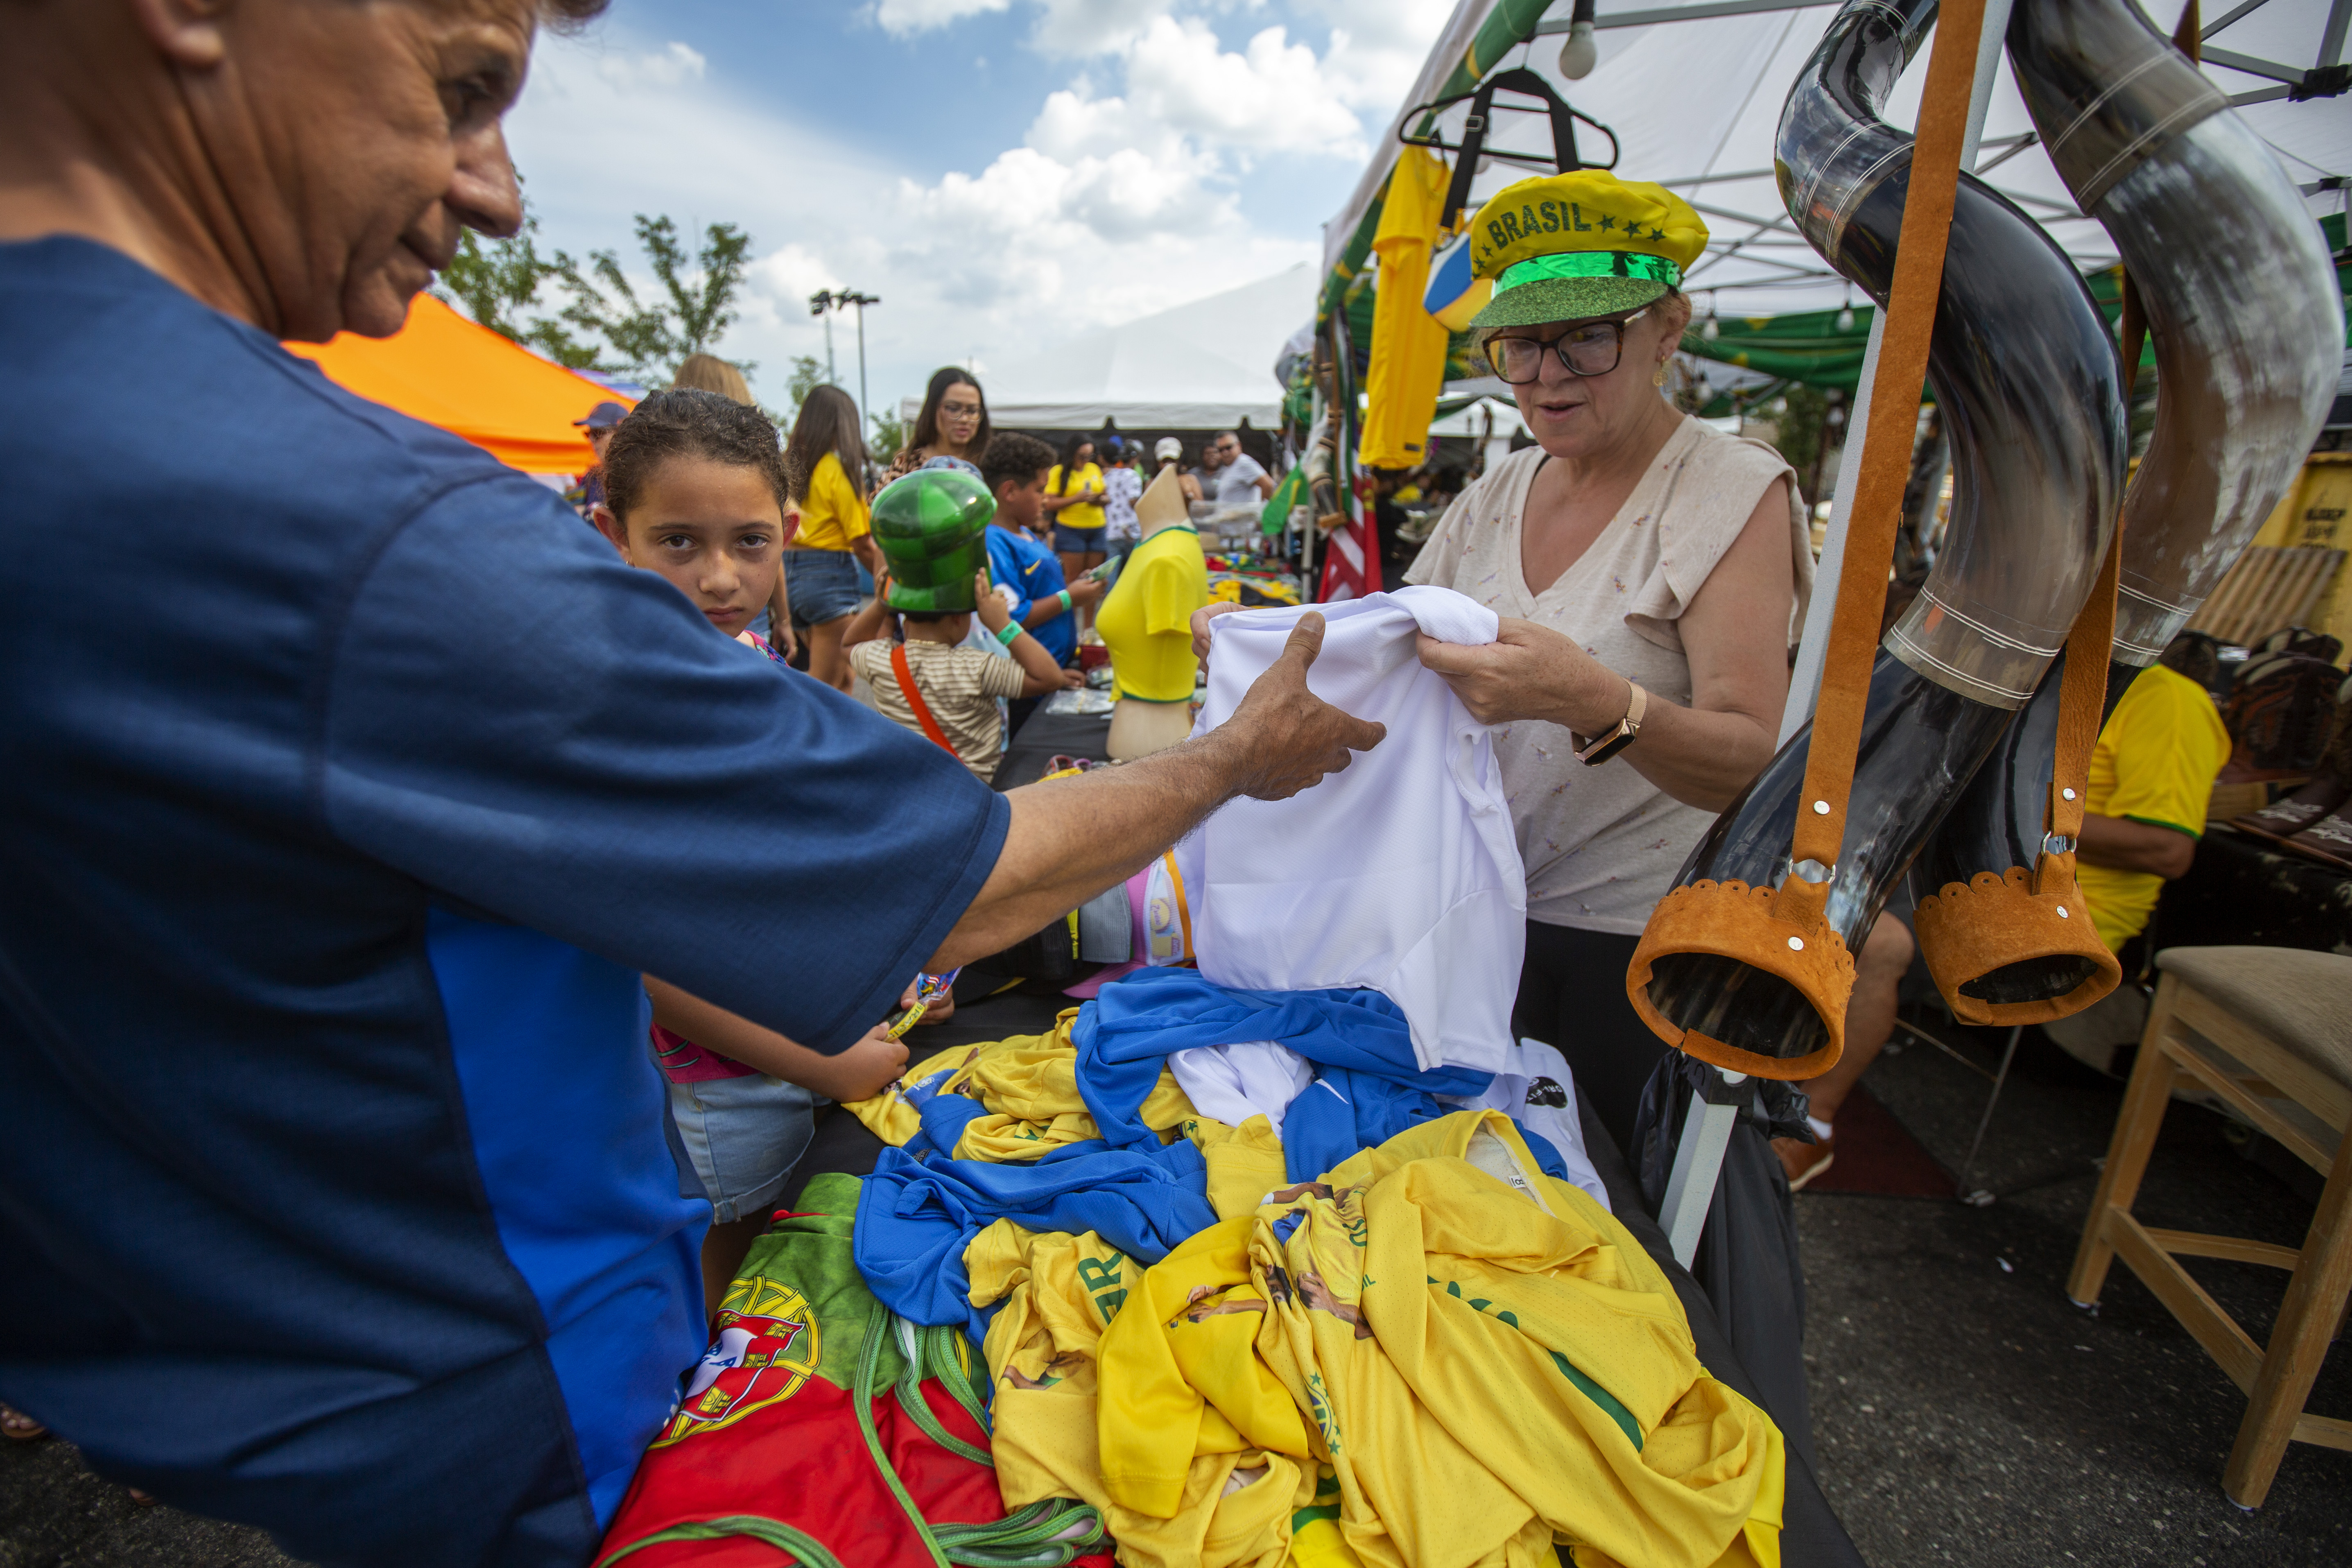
[955,261,1317,430]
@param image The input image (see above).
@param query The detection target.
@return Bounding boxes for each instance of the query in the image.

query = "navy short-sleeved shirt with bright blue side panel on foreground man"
[0,240,1006,1568]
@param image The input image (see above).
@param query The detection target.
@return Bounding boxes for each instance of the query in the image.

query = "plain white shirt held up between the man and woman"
[1194,588,1527,1072]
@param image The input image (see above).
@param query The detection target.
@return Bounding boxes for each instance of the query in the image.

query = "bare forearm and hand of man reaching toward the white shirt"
[929,613,1388,971]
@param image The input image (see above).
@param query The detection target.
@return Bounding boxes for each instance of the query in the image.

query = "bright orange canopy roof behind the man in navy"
[287,294,633,475]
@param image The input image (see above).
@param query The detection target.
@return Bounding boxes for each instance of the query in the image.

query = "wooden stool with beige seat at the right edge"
[2067,947,2352,1509]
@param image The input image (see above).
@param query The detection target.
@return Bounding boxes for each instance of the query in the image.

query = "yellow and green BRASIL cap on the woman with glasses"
[1468,169,1707,327]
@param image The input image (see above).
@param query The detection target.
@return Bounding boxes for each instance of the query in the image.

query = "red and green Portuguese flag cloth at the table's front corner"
[597,1175,1110,1568]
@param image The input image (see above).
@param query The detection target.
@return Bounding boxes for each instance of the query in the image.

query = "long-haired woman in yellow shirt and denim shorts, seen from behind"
[783,385,882,691]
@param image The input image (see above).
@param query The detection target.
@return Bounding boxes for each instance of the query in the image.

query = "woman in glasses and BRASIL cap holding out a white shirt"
[1407,169,1814,1147]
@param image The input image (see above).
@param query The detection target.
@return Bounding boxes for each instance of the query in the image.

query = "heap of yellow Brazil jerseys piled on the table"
[849,1034,1783,1568]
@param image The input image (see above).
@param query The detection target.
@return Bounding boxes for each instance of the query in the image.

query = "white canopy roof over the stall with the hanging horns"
[1324,0,2352,317]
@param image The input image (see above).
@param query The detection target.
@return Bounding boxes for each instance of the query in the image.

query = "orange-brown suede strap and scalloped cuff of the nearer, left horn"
[1625,0,1985,1079]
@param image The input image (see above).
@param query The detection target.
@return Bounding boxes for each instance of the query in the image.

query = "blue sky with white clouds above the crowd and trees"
[508,0,1454,407]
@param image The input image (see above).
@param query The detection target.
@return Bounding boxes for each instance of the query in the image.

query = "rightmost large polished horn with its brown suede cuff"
[1919,0,2343,1023]
